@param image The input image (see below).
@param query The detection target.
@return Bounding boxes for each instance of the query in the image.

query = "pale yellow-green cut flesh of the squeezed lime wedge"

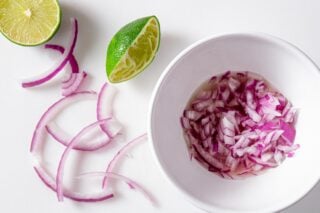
[107,16,160,83]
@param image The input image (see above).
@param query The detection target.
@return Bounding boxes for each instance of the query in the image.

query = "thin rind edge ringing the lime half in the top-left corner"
[0,0,62,46]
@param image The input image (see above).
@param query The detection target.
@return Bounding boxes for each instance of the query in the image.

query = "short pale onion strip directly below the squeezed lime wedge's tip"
[97,83,116,138]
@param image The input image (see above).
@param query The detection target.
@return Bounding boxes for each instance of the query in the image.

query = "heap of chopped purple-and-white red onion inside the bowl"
[180,71,299,179]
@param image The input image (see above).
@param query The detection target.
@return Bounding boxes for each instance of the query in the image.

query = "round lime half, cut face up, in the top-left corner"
[0,0,61,46]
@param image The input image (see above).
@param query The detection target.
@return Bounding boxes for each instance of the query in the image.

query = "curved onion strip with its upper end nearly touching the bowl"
[102,133,147,188]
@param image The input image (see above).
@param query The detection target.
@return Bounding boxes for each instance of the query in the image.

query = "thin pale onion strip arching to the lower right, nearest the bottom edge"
[78,172,155,204]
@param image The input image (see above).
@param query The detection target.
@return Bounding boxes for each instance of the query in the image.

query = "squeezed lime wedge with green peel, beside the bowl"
[106,16,160,83]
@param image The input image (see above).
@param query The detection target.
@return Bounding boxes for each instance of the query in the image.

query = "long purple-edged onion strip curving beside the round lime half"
[22,18,78,88]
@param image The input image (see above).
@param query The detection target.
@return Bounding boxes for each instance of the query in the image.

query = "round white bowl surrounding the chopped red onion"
[149,33,320,213]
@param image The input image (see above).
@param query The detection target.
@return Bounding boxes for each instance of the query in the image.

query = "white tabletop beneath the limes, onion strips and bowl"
[0,0,320,213]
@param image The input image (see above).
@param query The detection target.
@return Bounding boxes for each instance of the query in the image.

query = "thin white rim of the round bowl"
[147,32,320,213]
